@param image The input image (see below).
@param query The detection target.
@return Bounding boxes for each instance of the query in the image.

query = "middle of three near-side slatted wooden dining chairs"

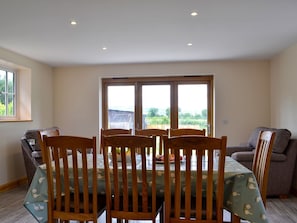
[103,135,163,223]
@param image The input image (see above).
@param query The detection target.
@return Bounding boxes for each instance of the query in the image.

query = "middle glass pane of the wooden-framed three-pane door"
[142,85,170,129]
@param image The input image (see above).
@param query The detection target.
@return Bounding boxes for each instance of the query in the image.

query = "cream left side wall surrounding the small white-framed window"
[0,48,53,186]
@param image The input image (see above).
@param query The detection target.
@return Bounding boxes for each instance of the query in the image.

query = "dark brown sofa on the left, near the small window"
[21,127,60,185]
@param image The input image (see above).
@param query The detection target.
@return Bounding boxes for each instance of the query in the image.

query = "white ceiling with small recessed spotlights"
[0,0,297,66]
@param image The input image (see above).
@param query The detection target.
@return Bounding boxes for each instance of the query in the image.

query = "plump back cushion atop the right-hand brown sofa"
[248,127,291,153]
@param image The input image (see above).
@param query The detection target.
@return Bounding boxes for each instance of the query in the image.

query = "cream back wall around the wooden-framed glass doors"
[54,61,270,145]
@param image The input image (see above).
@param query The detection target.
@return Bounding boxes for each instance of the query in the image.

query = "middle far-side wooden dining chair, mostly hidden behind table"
[135,129,169,155]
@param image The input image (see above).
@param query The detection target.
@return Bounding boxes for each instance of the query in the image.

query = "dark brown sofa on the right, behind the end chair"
[227,127,297,197]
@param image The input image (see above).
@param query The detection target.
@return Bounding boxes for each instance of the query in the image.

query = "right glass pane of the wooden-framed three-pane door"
[178,84,208,132]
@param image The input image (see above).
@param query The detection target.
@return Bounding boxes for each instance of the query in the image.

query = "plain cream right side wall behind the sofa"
[271,44,297,191]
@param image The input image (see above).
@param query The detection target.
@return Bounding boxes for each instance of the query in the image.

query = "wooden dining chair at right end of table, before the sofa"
[232,131,275,223]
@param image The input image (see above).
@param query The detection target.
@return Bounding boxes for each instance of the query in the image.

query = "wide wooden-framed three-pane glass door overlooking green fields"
[102,76,213,134]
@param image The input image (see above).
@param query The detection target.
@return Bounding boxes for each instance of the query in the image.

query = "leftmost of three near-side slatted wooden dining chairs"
[43,135,105,222]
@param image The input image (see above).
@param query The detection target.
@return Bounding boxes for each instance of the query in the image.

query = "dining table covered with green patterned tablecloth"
[23,154,268,223]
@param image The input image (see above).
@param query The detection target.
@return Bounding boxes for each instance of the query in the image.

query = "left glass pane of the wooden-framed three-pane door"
[107,85,135,129]
